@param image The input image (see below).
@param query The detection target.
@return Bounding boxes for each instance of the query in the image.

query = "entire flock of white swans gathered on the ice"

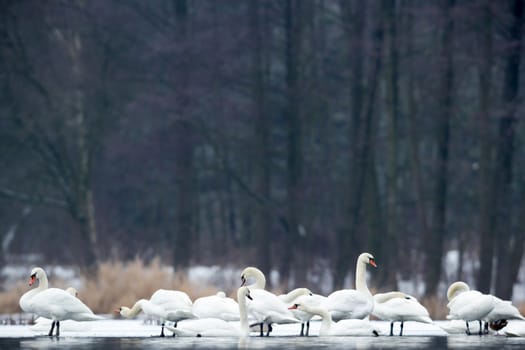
[19,253,525,337]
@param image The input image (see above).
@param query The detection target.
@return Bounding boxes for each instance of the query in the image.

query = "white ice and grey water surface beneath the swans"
[0,320,525,350]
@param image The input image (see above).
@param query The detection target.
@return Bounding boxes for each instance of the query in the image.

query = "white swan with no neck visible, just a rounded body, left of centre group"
[192,292,239,321]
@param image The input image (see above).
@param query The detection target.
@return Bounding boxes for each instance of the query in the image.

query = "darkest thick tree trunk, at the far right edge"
[495,0,524,299]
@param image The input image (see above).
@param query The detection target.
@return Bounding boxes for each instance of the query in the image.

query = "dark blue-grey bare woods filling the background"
[0,0,525,298]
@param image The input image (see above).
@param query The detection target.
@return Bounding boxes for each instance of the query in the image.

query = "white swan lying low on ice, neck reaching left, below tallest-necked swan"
[290,303,379,337]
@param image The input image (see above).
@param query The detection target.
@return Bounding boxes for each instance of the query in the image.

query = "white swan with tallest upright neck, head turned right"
[321,253,377,321]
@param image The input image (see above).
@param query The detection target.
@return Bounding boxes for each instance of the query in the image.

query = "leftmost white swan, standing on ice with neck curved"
[20,268,103,337]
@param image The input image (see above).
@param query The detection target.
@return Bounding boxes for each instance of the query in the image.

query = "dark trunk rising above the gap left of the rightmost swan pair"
[425,0,454,296]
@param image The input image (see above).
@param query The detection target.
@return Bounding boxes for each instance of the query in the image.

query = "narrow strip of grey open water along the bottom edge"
[0,335,525,350]
